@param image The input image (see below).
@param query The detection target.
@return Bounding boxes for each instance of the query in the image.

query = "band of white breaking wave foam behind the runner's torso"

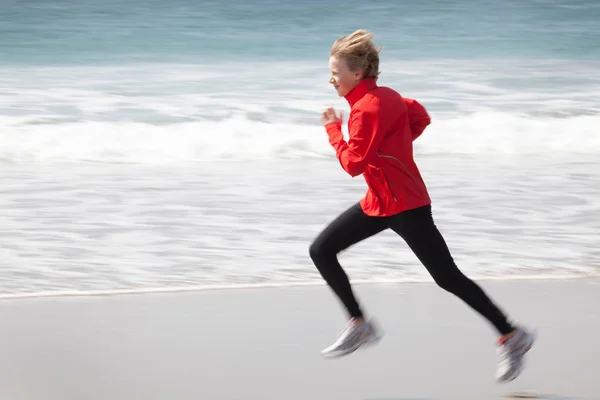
[0,112,600,163]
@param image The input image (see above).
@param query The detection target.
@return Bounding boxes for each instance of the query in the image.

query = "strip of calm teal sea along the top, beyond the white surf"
[0,0,600,65]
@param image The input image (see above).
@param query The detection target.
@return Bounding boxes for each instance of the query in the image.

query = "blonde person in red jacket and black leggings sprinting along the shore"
[310,30,535,382]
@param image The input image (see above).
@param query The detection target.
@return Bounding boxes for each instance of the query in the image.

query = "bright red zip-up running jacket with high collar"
[325,79,431,216]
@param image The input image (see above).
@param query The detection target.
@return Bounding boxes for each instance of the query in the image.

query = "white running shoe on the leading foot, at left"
[321,319,381,358]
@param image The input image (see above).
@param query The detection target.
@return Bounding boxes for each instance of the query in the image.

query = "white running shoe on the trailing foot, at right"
[496,328,535,383]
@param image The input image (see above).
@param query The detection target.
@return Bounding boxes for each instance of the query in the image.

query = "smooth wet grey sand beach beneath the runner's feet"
[0,280,600,400]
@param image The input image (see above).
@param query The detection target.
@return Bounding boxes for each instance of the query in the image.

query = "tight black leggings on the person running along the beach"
[310,204,514,335]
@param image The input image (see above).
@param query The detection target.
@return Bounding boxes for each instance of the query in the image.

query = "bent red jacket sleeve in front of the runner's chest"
[325,106,385,177]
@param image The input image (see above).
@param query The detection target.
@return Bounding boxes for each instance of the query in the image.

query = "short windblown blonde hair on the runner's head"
[329,29,381,80]
